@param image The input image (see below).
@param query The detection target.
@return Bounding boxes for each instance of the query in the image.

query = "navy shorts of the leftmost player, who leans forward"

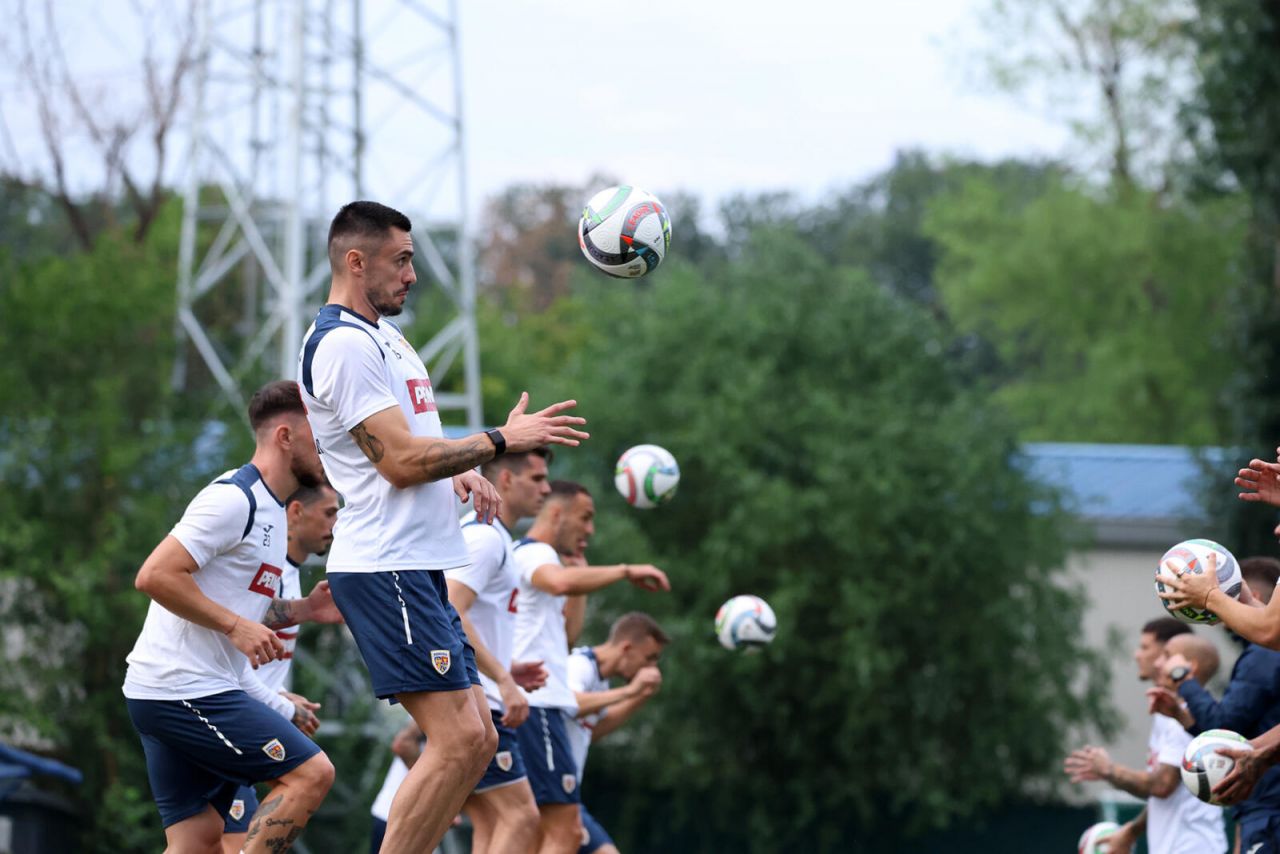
[125,691,320,827]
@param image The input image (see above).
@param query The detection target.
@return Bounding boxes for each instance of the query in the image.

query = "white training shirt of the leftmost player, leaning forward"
[123,465,294,718]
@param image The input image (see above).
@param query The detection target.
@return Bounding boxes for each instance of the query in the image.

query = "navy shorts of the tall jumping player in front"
[328,570,480,699]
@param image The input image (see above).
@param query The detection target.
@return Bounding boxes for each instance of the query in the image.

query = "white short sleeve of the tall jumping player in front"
[311,326,399,430]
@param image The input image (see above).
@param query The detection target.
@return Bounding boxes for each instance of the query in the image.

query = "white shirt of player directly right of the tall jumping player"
[444,511,520,712]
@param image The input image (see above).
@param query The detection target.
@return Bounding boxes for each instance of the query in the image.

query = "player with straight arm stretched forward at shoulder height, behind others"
[513,480,671,854]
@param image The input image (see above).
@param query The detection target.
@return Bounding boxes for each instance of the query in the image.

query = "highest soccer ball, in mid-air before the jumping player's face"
[577,184,671,279]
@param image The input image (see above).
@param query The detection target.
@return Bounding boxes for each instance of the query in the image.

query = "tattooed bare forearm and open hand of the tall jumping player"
[351,392,589,489]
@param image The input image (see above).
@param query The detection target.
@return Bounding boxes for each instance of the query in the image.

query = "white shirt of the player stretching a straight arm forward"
[512,536,577,714]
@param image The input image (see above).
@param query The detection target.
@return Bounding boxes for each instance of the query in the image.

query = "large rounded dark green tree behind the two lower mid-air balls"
[529,228,1106,851]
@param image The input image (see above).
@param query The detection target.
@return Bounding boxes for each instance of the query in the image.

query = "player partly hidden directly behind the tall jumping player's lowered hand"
[444,448,552,854]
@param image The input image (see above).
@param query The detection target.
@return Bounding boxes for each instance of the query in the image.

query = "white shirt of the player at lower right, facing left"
[1147,714,1226,854]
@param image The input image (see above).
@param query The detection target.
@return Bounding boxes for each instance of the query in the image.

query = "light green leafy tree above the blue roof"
[927,172,1249,444]
